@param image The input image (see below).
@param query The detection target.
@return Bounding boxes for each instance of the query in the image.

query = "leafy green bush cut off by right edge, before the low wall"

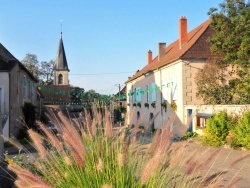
[231,111,250,149]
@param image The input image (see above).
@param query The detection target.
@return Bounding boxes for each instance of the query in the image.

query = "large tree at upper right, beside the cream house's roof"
[196,0,250,104]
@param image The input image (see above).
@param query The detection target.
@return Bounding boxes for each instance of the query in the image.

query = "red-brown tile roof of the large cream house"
[126,19,211,83]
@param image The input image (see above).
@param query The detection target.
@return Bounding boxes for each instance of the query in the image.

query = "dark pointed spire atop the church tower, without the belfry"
[54,32,69,71]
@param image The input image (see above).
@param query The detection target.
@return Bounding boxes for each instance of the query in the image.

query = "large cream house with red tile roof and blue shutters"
[126,17,217,136]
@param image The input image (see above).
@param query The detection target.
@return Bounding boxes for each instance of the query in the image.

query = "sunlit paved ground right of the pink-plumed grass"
[173,140,250,188]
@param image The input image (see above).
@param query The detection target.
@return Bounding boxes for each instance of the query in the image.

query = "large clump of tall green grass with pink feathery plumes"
[3,107,246,188]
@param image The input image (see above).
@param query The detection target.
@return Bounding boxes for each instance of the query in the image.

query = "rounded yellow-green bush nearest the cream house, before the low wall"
[202,111,229,146]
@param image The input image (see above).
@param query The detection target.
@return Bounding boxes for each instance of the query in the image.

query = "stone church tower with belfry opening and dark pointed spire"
[53,32,69,85]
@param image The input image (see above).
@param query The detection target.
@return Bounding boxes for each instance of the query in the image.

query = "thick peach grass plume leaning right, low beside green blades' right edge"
[141,153,162,184]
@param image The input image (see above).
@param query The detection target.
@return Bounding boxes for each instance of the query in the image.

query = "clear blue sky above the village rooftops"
[0,0,223,94]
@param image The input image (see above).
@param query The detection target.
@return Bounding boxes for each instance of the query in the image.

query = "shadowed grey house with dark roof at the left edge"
[0,43,37,138]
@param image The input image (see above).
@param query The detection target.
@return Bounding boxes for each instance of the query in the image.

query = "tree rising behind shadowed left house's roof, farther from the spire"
[21,53,40,79]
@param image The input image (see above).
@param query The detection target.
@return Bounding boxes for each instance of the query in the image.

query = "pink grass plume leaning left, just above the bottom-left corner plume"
[28,129,48,158]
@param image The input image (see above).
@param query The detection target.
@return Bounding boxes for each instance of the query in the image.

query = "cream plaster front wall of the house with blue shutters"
[127,61,183,134]
